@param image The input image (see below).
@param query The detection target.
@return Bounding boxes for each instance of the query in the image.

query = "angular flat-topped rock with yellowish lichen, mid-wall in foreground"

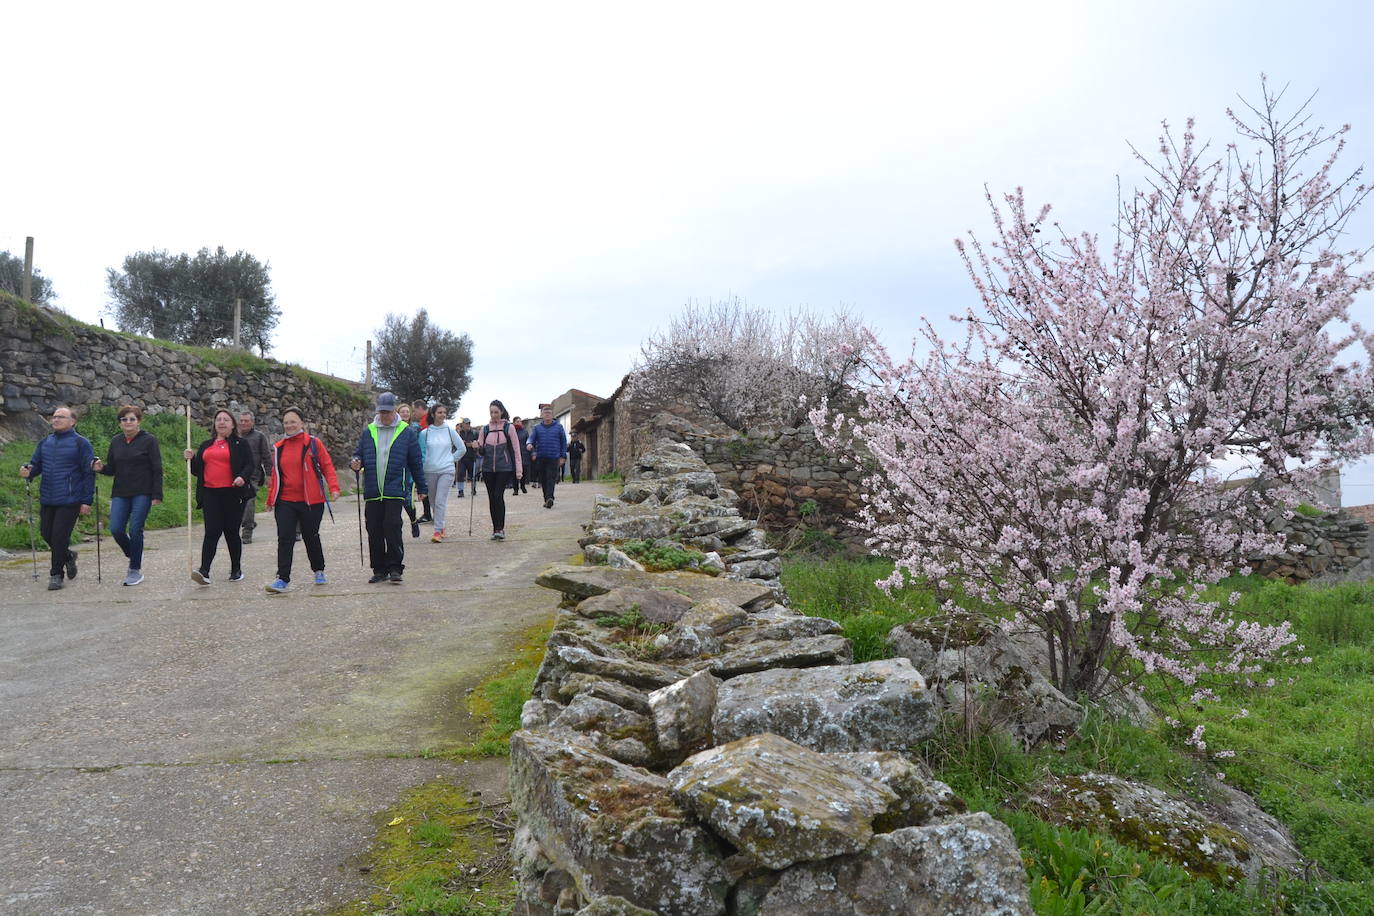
[668,735,897,869]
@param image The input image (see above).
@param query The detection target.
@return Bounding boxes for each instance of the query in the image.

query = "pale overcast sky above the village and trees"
[8,0,1374,504]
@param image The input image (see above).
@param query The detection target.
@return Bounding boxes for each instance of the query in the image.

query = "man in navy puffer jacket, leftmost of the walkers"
[19,407,95,592]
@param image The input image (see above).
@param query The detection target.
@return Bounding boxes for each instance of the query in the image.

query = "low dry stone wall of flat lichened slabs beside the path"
[511,445,1031,916]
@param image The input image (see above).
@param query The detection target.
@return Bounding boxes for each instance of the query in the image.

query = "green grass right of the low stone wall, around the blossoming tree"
[783,558,1374,916]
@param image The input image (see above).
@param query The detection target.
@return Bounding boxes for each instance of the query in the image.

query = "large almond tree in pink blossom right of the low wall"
[812,85,1374,700]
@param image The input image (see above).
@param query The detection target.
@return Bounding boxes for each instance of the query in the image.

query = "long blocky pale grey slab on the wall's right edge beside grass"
[712,659,936,751]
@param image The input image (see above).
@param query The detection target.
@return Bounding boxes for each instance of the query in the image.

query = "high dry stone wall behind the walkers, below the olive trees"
[0,297,372,455]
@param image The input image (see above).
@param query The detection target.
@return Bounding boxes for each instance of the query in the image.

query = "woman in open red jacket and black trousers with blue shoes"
[267,407,339,595]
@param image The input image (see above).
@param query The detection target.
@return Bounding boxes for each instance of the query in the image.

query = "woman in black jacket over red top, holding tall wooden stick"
[185,408,253,585]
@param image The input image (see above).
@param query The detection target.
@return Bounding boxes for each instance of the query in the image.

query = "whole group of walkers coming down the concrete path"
[19,391,585,593]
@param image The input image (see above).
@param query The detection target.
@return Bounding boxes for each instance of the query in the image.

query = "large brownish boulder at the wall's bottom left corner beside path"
[510,732,728,916]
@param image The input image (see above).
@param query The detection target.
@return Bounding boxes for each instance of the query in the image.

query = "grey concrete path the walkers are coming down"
[0,483,610,916]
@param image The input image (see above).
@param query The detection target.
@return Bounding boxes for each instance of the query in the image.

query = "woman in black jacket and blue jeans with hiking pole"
[95,404,162,585]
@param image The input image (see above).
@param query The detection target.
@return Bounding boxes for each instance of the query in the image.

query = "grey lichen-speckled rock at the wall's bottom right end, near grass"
[758,812,1032,916]
